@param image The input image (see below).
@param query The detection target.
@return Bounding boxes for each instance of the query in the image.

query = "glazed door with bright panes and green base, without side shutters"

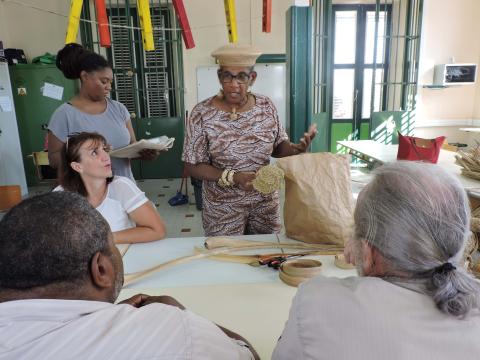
[330,4,391,152]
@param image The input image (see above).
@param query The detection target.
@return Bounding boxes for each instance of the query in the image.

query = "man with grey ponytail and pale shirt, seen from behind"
[273,162,480,360]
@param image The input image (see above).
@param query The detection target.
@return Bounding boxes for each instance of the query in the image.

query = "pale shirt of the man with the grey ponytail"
[272,276,480,360]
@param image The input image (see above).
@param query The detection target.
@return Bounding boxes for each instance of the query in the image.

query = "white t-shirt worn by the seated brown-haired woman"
[53,176,148,232]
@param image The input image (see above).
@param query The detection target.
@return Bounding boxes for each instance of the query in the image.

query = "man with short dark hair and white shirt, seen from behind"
[0,192,258,360]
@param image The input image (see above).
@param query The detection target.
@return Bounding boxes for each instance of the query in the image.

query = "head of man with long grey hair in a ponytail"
[353,162,479,316]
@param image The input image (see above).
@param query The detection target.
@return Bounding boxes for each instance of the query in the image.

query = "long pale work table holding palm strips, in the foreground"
[119,235,356,359]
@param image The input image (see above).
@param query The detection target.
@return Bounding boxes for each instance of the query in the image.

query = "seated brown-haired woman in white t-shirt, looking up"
[54,132,165,244]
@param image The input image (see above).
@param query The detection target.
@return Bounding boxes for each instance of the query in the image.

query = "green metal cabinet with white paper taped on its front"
[10,64,78,186]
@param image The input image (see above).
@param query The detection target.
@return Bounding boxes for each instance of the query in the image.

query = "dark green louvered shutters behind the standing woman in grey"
[81,0,178,118]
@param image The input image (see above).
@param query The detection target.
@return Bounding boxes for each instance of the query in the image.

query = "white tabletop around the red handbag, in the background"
[338,140,480,197]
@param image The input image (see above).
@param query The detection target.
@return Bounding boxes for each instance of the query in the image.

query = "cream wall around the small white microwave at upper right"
[418,0,480,123]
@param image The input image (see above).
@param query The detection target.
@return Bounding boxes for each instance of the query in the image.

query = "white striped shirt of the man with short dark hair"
[0,299,253,360]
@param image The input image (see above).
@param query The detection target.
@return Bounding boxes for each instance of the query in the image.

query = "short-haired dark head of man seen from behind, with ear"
[0,192,123,302]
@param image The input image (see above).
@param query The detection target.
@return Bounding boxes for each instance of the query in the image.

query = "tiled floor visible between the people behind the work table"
[0,168,370,237]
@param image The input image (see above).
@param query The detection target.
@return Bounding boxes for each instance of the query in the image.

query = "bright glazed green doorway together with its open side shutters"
[306,0,423,152]
